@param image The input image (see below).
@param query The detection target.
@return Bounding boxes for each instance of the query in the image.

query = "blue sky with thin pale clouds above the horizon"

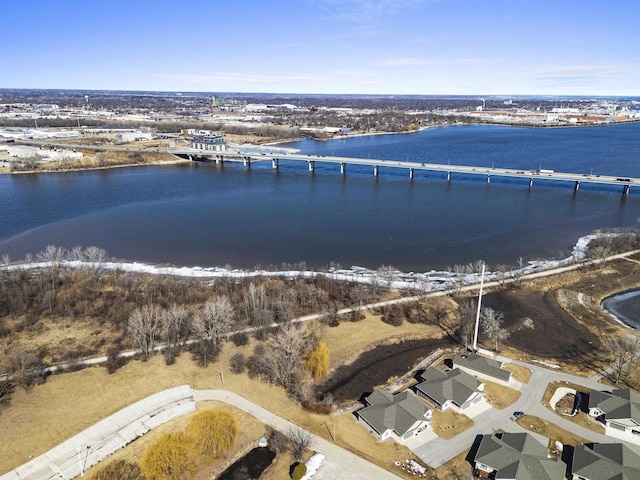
[0,0,640,95]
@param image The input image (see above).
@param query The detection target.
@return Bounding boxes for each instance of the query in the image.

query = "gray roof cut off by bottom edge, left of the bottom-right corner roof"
[474,433,567,480]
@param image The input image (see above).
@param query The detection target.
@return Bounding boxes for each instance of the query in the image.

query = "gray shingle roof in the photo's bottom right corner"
[571,443,640,480]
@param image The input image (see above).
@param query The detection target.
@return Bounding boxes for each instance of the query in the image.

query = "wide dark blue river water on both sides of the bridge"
[0,124,640,271]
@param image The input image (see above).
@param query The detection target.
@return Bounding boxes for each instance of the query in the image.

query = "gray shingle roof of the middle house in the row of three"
[415,367,481,406]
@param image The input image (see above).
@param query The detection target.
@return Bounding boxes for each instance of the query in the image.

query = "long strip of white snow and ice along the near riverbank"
[2,235,596,292]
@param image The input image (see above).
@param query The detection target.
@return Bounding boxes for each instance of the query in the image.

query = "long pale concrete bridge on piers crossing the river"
[171,149,640,195]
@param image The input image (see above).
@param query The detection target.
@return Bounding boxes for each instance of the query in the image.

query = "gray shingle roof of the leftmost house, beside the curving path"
[358,390,429,436]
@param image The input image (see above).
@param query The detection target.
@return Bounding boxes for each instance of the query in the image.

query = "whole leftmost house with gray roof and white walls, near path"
[355,390,431,442]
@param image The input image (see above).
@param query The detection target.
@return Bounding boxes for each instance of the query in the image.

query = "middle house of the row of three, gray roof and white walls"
[415,367,484,412]
